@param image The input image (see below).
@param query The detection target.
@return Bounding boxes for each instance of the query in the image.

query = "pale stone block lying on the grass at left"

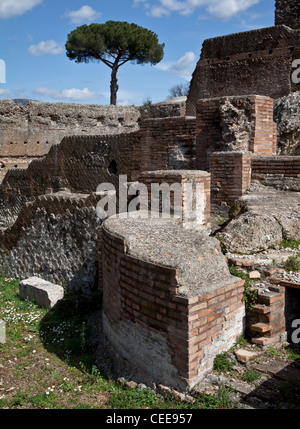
[19,277,64,308]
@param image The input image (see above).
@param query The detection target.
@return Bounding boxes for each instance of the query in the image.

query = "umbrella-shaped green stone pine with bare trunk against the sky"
[66,21,164,105]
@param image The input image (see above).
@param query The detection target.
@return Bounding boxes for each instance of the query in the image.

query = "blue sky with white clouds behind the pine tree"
[0,0,275,106]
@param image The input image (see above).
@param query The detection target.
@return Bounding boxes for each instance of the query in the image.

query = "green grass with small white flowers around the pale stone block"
[0,276,228,409]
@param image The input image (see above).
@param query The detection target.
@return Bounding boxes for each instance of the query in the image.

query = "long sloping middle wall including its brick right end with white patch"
[2,117,195,196]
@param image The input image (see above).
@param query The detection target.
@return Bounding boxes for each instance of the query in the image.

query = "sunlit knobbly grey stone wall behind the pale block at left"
[0,193,100,294]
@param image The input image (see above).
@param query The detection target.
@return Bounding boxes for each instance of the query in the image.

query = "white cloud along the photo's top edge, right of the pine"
[134,0,260,20]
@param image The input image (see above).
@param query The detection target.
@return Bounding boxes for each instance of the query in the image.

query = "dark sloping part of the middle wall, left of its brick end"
[2,133,138,196]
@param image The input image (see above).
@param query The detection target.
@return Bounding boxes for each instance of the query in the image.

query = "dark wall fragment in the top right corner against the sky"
[275,0,300,29]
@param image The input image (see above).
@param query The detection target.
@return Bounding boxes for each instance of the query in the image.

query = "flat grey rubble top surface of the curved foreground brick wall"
[104,216,241,297]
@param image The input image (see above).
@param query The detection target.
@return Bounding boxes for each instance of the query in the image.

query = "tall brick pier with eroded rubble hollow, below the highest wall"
[196,95,277,171]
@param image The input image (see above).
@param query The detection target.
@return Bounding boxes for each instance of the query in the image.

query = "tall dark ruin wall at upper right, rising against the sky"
[186,25,300,115]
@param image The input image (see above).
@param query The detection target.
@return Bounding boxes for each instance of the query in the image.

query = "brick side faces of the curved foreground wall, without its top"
[101,219,245,390]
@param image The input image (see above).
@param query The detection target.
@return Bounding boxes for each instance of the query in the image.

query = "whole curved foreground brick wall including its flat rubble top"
[100,219,245,390]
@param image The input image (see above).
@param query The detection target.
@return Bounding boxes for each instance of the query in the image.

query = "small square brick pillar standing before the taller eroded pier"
[210,152,252,209]
